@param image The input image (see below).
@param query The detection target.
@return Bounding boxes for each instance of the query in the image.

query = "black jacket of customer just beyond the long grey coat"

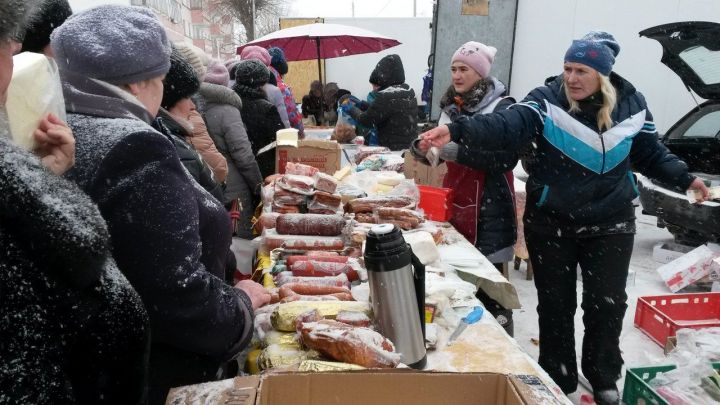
[233,83,284,178]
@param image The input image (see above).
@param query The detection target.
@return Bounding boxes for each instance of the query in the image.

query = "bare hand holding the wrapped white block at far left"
[33,113,75,175]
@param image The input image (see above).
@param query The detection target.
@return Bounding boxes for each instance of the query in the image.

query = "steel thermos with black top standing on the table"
[364,224,427,369]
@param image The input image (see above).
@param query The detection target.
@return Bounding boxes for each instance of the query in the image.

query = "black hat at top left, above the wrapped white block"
[21,0,72,53]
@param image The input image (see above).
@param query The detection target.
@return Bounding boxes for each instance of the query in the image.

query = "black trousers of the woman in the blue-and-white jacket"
[525,228,634,393]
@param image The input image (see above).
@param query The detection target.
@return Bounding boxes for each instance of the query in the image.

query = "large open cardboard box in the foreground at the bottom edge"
[165,369,558,405]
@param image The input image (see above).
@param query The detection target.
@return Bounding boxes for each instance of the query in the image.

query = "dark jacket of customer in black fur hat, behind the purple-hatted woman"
[152,108,223,201]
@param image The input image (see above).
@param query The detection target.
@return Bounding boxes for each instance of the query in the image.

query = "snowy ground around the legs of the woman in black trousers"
[510,207,673,404]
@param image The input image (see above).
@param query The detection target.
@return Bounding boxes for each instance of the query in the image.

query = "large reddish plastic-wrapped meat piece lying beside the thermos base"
[300,320,400,368]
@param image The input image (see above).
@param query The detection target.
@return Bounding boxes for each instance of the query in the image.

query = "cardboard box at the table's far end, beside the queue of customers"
[275,139,342,175]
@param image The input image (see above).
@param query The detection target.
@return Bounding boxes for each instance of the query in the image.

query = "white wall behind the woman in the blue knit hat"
[510,0,720,133]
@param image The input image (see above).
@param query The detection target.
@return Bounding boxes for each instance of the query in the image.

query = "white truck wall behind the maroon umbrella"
[326,17,431,104]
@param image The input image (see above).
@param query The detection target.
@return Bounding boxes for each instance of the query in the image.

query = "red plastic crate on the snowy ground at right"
[635,293,720,347]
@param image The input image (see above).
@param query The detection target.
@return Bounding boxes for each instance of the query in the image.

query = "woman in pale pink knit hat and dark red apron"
[410,41,518,336]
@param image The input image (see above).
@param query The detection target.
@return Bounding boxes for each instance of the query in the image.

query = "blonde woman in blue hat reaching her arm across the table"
[419,31,708,405]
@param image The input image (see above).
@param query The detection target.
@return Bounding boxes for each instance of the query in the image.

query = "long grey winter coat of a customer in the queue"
[200,83,263,238]
